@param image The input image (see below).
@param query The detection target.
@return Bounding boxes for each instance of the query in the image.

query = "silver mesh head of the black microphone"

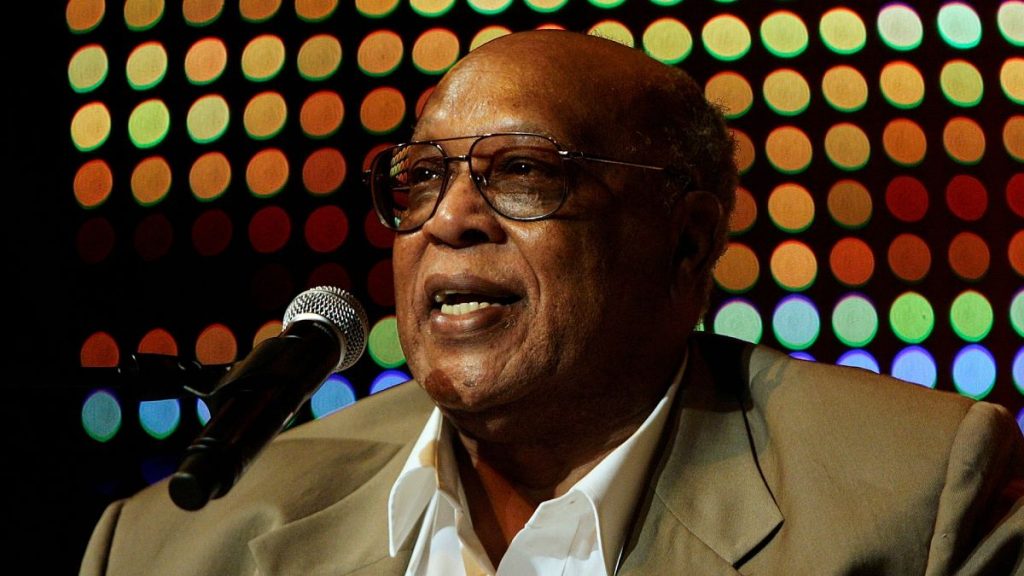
[284,286,369,372]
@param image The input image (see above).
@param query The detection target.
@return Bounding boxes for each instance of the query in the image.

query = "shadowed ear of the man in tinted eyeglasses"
[672,191,725,295]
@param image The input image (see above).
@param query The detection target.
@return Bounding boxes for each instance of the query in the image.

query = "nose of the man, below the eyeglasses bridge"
[423,159,505,248]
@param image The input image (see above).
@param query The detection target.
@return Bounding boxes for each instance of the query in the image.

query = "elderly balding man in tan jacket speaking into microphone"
[82,31,1024,576]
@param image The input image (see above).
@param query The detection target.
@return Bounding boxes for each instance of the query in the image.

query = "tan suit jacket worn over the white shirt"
[81,334,1024,576]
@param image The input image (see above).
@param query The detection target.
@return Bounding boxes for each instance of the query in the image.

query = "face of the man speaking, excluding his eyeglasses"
[393,48,688,429]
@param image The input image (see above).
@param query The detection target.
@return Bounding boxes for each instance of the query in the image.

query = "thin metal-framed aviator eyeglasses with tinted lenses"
[364,132,689,232]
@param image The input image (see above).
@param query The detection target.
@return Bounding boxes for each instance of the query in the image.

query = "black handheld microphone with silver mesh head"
[163,286,368,510]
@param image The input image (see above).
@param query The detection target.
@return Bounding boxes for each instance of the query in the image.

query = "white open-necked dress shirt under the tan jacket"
[388,360,686,576]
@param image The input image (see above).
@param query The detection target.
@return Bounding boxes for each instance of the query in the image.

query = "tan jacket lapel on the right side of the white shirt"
[622,335,782,574]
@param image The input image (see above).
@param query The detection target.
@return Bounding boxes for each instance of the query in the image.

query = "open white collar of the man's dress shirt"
[388,355,688,574]
